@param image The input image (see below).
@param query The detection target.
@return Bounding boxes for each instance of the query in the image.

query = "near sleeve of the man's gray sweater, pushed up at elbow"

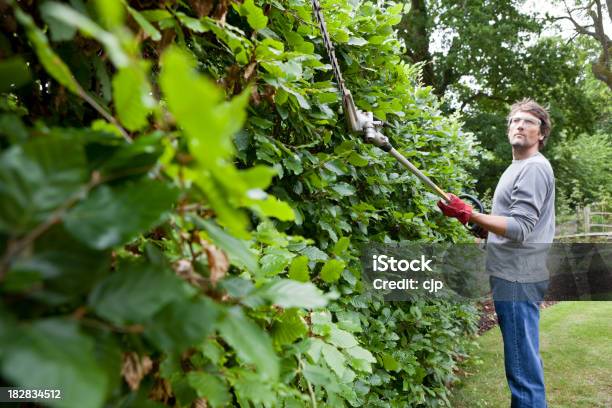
[506,163,554,242]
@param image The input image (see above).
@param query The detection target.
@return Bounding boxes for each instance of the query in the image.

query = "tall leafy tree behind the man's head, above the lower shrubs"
[398,0,610,204]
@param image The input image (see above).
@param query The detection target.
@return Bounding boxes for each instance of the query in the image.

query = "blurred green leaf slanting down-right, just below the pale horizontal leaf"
[219,307,280,382]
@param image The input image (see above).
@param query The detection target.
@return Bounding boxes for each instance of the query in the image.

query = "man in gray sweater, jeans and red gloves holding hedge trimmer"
[438,99,555,408]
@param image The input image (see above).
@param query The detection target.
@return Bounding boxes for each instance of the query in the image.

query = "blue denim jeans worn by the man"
[490,276,548,408]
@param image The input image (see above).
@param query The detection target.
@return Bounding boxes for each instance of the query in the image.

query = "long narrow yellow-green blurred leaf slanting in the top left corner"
[15,7,83,95]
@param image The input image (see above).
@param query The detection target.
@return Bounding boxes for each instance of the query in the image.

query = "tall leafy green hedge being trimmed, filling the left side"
[0,0,478,407]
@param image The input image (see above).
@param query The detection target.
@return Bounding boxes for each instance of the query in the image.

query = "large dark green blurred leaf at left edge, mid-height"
[0,135,87,235]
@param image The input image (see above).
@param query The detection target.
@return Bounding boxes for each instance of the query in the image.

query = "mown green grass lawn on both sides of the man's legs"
[451,302,612,408]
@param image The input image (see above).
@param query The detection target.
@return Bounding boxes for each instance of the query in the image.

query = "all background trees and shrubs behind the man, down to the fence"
[397,0,612,206]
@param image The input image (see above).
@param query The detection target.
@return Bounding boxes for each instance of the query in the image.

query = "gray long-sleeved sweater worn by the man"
[487,152,555,283]
